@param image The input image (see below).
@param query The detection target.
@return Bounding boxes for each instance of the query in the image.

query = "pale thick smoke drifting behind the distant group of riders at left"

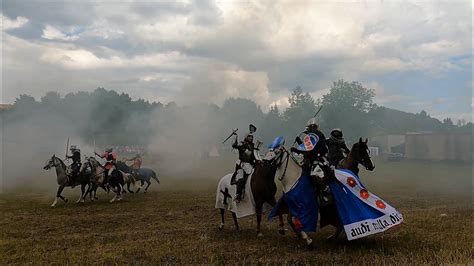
[2,89,264,191]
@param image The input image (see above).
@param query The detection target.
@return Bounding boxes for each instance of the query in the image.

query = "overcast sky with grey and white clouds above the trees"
[1,0,474,120]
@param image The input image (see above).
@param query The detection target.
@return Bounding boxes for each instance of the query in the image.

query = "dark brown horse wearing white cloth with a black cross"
[216,154,285,236]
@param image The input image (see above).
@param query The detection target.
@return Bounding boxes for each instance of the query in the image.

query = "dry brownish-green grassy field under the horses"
[0,159,473,264]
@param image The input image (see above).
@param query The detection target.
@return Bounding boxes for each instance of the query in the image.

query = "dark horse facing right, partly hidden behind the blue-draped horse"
[320,138,375,239]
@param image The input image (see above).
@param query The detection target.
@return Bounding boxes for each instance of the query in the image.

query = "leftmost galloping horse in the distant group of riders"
[43,154,90,207]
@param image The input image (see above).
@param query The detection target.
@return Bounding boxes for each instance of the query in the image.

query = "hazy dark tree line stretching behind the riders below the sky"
[1,80,472,149]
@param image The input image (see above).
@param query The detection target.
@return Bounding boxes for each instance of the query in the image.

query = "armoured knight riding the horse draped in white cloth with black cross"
[231,125,257,202]
